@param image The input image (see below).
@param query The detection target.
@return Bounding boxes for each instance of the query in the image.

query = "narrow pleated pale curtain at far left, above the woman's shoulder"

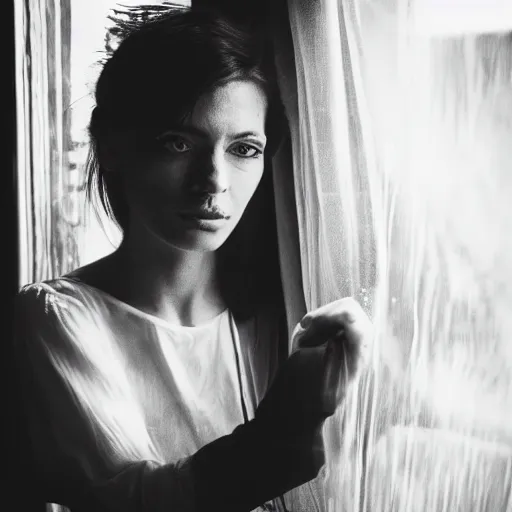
[15,0,77,285]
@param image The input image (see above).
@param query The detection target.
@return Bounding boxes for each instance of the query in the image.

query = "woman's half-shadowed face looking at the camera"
[110,81,267,251]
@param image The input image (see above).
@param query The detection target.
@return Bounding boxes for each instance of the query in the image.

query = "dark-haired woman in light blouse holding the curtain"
[16,7,367,512]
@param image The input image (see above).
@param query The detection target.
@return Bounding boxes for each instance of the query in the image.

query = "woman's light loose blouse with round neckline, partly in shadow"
[15,277,288,512]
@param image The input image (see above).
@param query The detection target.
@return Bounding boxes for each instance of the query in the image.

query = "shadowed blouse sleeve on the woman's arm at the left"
[14,284,194,512]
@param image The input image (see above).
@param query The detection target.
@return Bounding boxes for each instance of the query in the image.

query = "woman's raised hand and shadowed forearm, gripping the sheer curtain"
[256,298,373,475]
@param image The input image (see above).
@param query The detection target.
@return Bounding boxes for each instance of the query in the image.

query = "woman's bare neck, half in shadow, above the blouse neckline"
[76,230,226,326]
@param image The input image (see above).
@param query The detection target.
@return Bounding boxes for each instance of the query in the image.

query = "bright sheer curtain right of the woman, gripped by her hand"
[276,0,512,512]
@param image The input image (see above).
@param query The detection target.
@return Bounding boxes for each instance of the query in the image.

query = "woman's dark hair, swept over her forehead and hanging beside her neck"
[87,3,286,324]
